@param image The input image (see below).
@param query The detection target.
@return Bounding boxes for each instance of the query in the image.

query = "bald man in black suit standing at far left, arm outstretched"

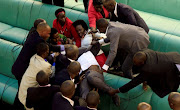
[11,23,64,85]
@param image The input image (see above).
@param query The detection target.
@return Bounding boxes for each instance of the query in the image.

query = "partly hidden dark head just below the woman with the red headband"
[49,28,60,45]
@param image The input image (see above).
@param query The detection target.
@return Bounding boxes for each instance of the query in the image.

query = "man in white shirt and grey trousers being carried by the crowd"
[78,46,120,106]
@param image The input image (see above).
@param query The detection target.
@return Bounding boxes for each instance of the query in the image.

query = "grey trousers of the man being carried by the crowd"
[80,70,112,99]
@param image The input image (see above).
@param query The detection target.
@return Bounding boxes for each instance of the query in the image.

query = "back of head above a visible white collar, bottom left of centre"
[60,80,75,99]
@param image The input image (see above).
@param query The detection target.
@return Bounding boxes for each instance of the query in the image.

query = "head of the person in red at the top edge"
[93,0,103,12]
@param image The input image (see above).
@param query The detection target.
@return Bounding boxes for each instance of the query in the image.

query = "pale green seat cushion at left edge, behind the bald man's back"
[0,27,29,44]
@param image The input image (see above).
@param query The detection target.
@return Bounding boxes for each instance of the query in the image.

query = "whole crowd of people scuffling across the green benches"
[12,0,180,110]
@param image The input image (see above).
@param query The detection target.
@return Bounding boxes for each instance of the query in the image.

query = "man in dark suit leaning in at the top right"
[103,0,149,33]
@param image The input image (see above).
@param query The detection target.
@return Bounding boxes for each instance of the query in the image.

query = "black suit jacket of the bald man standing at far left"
[11,31,61,82]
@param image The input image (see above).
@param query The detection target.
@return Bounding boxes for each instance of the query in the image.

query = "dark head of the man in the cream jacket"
[36,42,49,56]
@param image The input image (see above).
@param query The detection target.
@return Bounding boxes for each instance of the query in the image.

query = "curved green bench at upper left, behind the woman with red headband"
[0,0,89,44]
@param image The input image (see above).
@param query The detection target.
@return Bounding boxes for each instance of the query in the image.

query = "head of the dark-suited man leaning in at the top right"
[103,0,116,13]
